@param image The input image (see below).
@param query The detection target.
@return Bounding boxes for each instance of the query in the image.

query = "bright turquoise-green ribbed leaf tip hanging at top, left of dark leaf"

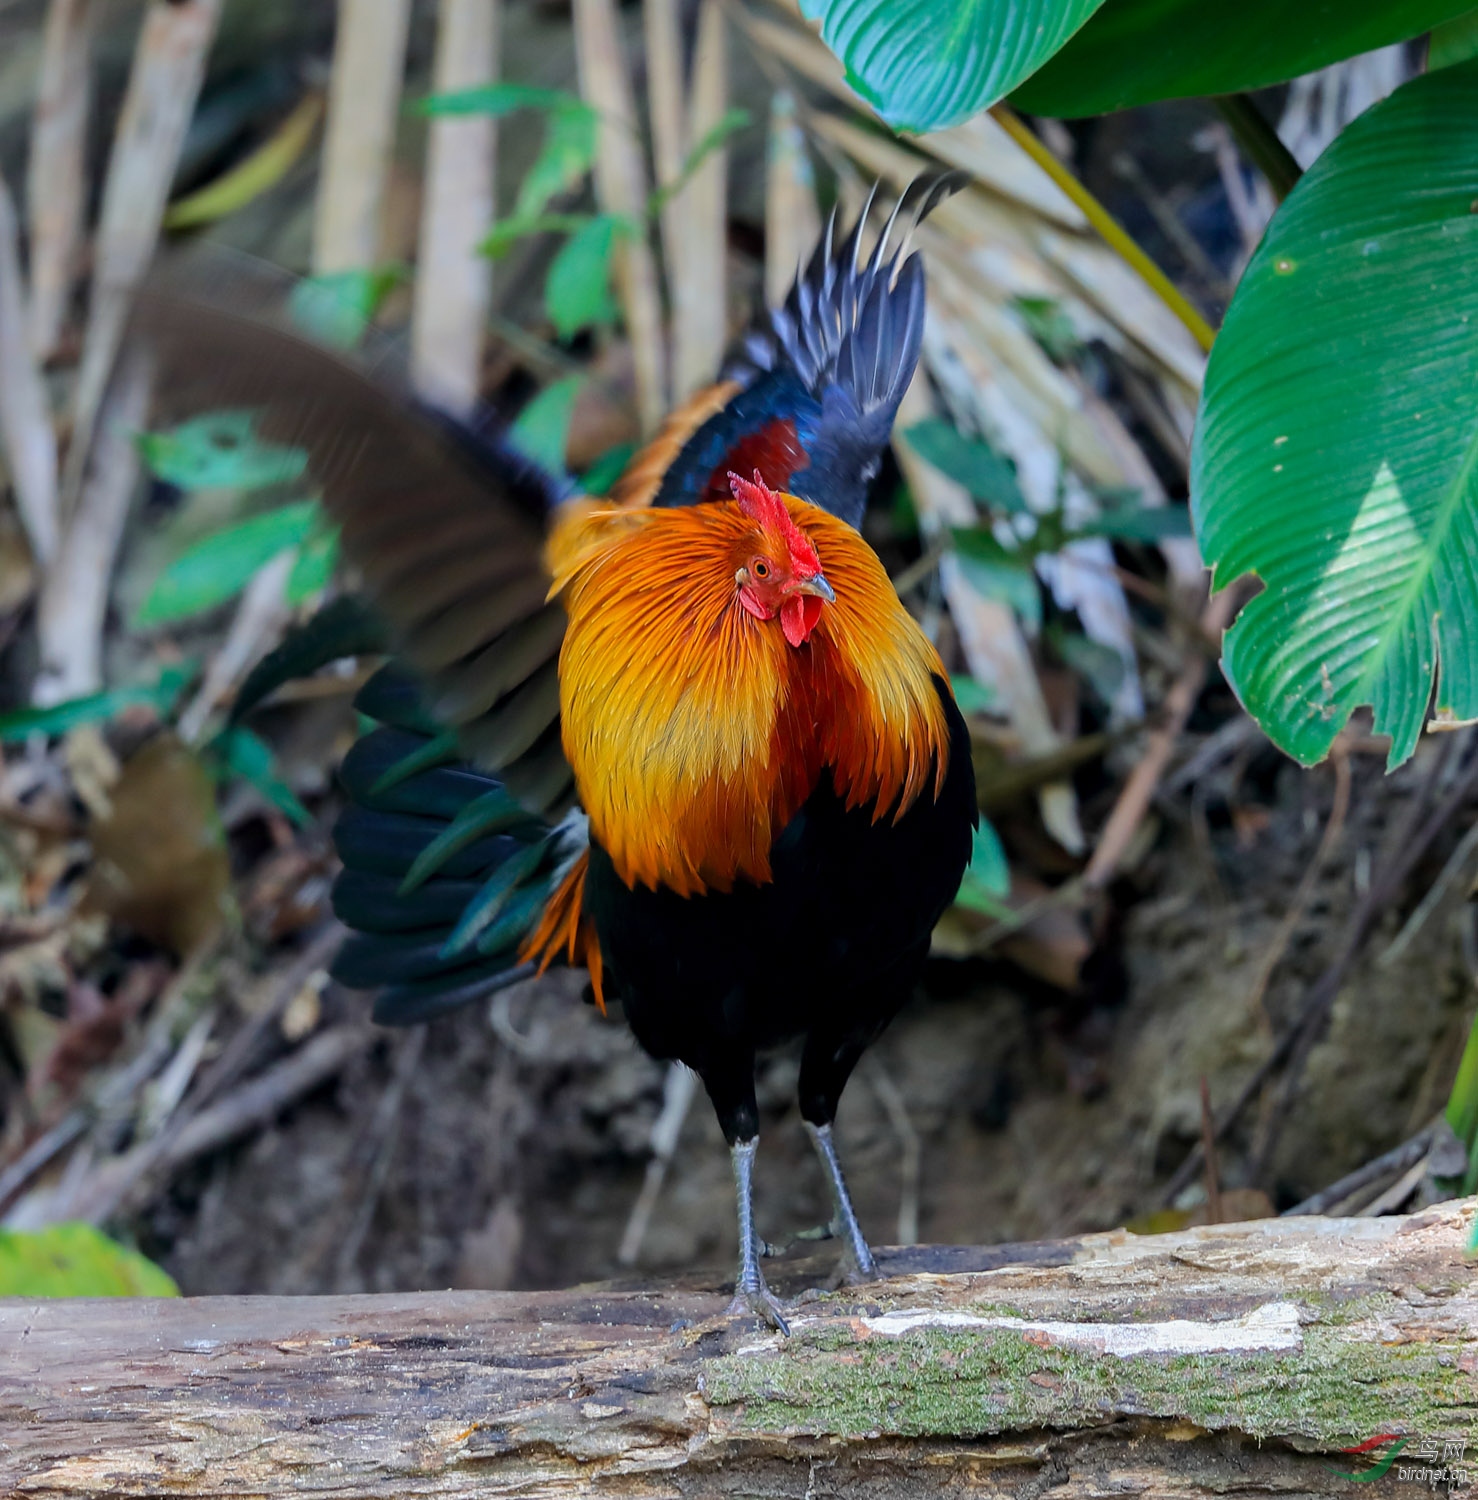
[804,0,1103,131]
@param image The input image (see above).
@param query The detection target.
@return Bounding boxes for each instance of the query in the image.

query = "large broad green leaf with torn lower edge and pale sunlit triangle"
[1191,62,1478,765]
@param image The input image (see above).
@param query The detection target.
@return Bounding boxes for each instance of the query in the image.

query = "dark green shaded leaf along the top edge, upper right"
[1011,0,1472,117]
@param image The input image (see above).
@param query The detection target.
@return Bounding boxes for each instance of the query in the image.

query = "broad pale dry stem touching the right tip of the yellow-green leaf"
[314,0,411,275]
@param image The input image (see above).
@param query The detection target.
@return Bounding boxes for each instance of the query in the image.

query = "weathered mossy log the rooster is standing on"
[0,1200,1478,1497]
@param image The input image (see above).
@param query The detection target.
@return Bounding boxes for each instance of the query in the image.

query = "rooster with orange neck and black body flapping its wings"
[135,177,977,1328]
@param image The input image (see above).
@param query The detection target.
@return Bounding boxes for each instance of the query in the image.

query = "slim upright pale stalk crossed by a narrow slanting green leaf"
[672,0,729,401]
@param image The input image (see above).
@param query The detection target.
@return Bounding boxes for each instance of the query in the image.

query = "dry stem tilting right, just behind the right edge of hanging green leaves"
[575,0,668,432]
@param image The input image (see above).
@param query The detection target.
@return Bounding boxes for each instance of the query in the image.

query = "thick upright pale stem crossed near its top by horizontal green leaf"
[411,0,503,414]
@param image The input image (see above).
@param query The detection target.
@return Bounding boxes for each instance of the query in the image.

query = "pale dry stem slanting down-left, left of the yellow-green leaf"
[62,0,222,519]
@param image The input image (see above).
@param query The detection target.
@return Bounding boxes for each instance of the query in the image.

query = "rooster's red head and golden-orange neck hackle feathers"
[549,492,948,896]
